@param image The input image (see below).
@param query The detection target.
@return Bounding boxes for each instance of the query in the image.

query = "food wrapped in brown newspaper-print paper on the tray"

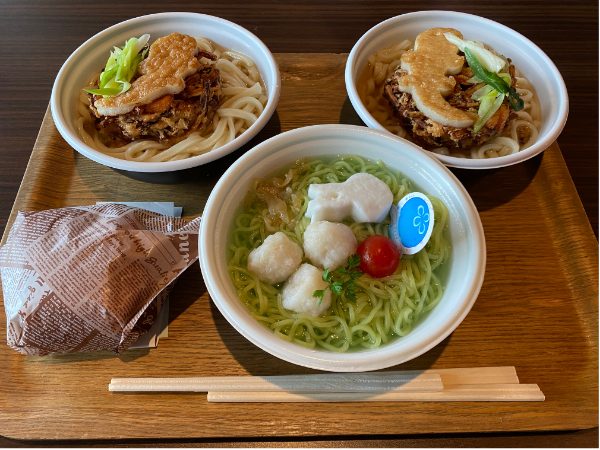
[0,204,200,355]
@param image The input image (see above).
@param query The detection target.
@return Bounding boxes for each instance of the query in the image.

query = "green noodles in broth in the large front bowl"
[228,156,450,352]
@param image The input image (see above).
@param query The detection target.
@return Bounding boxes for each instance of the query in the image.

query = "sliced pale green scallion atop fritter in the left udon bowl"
[84,34,150,97]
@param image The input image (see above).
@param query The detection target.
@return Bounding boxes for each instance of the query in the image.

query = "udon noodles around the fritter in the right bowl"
[357,40,540,159]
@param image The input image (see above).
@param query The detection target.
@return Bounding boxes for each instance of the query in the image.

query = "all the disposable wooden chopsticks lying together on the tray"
[108,366,545,403]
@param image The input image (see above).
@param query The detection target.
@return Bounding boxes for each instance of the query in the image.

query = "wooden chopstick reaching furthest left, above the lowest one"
[108,371,444,392]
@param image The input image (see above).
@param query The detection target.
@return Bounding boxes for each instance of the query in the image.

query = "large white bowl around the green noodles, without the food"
[198,125,486,372]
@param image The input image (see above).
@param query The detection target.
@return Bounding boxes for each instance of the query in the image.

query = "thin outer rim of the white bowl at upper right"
[344,10,569,170]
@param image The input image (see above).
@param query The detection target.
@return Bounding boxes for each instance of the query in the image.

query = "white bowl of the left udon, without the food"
[50,12,281,172]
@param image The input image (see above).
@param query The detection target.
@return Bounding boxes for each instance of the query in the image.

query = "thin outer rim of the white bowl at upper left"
[50,12,281,173]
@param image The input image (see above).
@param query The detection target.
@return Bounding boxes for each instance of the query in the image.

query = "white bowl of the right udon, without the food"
[345,11,569,169]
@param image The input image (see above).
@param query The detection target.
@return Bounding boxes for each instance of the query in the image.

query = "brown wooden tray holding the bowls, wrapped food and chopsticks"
[0,54,598,439]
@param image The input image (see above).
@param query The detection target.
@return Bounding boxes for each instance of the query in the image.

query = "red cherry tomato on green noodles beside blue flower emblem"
[356,234,400,278]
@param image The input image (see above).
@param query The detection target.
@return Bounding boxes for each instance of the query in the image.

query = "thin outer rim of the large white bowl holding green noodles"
[198,124,487,372]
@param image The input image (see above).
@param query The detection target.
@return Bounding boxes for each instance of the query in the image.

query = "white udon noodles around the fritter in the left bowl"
[77,38,267,162]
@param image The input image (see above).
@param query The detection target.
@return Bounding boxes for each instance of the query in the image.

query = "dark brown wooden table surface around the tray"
[0,0,598,447]
